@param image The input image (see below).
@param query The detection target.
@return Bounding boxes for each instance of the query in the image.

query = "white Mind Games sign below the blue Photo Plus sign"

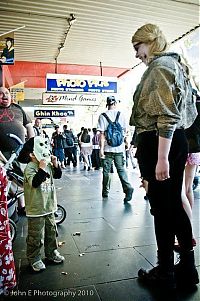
[42,93,102,106]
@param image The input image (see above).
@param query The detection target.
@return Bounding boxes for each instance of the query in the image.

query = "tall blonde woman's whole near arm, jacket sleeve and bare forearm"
[148,65,182,181]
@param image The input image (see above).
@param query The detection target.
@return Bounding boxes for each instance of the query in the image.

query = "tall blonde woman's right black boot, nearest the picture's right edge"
[174,250,199,288]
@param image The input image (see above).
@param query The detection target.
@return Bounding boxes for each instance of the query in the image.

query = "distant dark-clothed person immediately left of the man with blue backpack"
[91,128,100,170]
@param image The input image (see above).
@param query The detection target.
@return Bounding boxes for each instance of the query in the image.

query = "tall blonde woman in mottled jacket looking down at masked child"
[130,24,199,291]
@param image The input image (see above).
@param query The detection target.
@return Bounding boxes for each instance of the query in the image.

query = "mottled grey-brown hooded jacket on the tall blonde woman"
[130,53,197,138]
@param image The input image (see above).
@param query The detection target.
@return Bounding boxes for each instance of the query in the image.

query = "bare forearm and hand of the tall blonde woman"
[155,136,172,181]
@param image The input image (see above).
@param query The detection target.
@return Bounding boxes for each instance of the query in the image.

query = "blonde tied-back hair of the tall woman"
[132,24,169,57]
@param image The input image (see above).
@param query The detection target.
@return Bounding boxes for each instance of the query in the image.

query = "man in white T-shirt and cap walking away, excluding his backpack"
[97,96,133,202]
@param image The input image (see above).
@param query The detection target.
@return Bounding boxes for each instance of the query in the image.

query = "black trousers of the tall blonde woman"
[137,130,192,259]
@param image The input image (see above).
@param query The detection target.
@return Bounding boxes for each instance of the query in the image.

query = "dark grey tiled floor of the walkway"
[4,162,200,301]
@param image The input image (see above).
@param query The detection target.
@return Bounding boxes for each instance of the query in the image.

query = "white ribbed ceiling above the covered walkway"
[0,0,199,68]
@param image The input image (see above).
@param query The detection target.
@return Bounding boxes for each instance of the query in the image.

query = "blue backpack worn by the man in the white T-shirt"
[102,111,124,147]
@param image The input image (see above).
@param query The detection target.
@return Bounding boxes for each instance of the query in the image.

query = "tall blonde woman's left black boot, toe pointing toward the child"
[138,255,176,290]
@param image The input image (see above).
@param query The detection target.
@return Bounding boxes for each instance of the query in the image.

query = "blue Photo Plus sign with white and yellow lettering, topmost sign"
[46,73,117,94]
